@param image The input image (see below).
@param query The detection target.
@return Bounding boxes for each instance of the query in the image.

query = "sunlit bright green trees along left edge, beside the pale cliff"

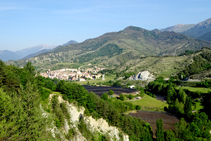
[0,61,50,140]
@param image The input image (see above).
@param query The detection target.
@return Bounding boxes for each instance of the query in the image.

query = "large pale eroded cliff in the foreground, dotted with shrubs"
[45,94,129,141]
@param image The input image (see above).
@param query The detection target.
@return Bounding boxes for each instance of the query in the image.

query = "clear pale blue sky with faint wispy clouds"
[0,0,211,51]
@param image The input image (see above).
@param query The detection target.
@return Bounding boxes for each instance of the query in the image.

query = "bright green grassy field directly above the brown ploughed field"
[128,95,168,111]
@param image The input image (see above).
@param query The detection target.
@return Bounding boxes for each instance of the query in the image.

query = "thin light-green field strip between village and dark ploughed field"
[75,74,116,85]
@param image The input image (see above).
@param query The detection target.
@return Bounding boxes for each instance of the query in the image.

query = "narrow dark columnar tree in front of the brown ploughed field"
[156,119,165,141]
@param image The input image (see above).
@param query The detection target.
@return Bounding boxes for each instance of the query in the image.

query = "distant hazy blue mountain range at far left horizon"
[0,44,56,61]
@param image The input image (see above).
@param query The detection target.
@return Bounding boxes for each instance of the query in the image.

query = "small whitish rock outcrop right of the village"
[128,71,154,80]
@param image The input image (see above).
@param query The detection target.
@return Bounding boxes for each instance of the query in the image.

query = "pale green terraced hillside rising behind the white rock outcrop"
[118,56,192,77]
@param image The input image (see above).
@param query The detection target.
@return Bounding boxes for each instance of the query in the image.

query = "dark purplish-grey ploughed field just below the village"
[83,85,139,97]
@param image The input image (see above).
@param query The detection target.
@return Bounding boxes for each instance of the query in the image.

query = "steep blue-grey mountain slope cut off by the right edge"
[182,18,211,38]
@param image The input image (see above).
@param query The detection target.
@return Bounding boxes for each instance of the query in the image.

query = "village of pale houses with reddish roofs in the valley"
[40,68,104,81]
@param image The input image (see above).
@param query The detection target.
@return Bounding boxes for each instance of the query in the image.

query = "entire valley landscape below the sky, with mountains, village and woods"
[0,19,211,141]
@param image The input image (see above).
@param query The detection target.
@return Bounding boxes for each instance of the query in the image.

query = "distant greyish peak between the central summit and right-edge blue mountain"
[160,24,195,33]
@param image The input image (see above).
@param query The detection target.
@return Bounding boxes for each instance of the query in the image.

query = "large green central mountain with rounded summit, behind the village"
[7,26,211,70]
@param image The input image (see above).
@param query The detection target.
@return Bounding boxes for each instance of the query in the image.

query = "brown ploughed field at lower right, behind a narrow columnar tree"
[129,111,179,135]
